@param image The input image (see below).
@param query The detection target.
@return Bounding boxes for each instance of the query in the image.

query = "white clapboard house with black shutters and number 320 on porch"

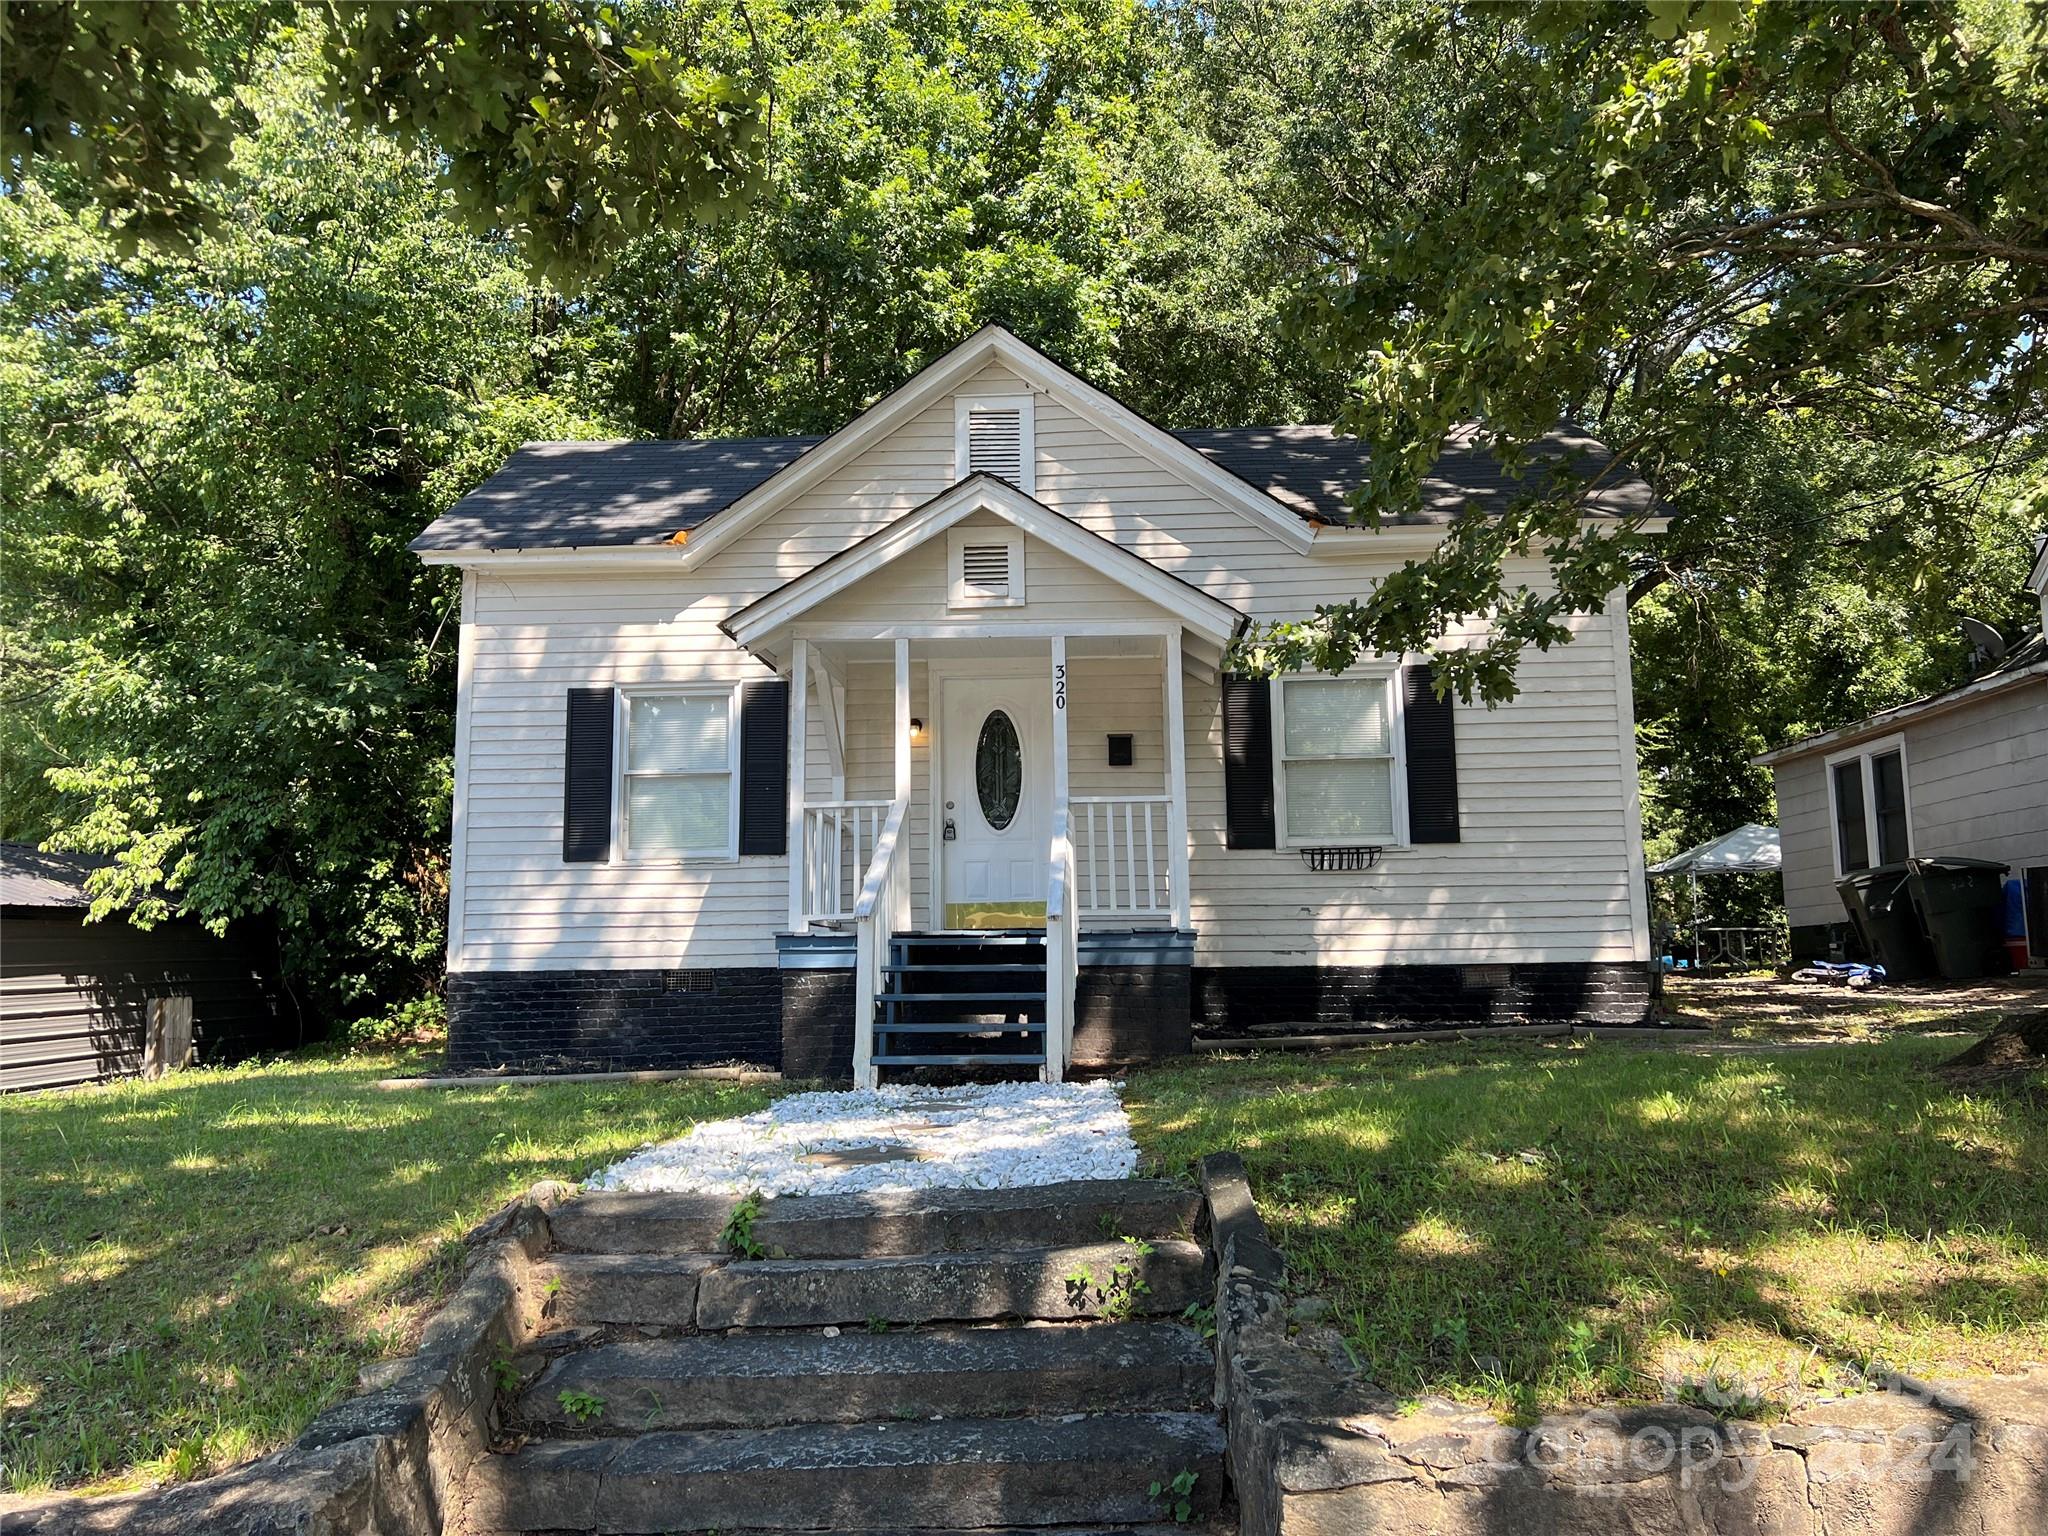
[414,328,1651,1081]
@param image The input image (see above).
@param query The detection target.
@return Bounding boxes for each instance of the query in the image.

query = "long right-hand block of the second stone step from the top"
[696,1239,1208,1331]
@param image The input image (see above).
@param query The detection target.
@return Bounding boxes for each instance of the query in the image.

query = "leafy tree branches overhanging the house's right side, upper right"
[1255,0,2048,700]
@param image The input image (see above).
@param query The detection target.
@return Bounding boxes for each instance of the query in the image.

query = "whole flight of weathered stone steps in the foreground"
[461,1180,1235,1536]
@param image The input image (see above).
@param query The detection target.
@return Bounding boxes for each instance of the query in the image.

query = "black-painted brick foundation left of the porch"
[449,967,782,1071]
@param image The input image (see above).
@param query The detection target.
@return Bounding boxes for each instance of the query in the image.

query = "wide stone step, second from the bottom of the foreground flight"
[520,1323,1217,1436]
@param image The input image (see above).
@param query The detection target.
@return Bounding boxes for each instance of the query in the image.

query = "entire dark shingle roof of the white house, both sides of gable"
[412,426,1655,551]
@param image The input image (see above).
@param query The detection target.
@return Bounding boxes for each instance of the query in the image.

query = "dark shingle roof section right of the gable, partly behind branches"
[1174,426,1655,524]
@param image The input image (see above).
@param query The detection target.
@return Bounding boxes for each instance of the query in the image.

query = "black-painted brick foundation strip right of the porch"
[1192,963,1651,1036]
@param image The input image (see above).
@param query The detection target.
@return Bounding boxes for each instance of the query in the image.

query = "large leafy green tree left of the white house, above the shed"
[0,39,592,1016]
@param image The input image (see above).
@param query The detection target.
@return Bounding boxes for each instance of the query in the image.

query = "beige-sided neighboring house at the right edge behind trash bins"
[1757,541,2048,963]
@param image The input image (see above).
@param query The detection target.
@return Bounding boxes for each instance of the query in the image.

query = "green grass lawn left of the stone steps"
[0,1057,768,1491]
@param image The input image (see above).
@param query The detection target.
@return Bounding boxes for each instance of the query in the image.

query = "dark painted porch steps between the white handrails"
[874,928,1047,1075]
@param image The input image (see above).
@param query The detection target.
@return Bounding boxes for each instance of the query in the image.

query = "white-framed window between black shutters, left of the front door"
[621,688,737,858]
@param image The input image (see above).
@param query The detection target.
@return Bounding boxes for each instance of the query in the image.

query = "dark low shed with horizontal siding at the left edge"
[0,842,297,1090]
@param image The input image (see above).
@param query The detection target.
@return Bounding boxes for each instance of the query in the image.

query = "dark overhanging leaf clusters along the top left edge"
[0,0,766,276]
